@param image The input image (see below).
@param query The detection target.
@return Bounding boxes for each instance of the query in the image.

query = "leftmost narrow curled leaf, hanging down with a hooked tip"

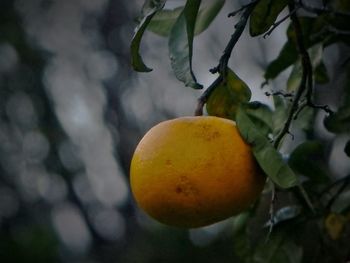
[130,0,166,72]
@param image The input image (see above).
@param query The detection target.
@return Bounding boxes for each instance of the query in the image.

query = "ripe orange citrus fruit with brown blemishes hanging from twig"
[130,116,265,228]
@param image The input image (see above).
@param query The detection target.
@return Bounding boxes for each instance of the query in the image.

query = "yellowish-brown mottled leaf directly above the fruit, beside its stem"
[206,69,251,120]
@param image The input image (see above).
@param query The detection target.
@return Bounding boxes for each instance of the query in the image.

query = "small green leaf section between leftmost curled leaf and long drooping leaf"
[147,6,184,37]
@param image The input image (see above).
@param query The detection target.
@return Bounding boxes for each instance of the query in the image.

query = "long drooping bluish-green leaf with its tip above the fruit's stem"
[169,0,202,89]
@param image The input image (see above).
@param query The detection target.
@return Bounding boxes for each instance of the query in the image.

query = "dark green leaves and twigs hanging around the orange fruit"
[131,0,350,263]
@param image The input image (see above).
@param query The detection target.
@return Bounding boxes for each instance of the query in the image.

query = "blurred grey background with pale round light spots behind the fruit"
[0,0,348,263]
